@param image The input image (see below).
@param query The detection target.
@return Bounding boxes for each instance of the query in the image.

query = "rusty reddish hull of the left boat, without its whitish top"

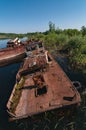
[0,46,26,67]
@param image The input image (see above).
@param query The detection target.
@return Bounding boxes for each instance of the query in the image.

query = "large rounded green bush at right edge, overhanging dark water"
[65,36,86,70]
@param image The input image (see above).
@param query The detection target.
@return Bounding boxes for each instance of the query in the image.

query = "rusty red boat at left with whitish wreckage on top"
[0,38,28,67]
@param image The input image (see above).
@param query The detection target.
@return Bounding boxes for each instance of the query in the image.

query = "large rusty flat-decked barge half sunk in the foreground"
[7,43,81,120]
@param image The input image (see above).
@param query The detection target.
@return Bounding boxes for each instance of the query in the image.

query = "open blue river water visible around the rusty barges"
[0,39,86,130]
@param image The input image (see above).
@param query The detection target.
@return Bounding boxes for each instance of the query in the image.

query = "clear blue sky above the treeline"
[0,0,86,33]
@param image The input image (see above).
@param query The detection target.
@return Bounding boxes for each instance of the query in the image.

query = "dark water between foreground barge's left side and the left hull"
[0,63,20,130]
